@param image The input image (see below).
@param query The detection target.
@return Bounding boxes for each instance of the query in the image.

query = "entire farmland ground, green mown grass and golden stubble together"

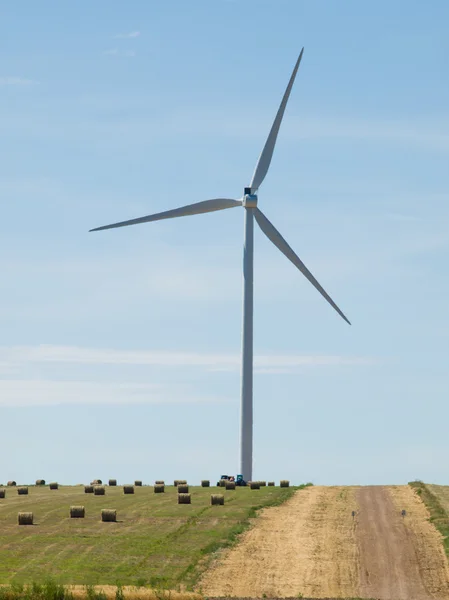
[0,482,449,600]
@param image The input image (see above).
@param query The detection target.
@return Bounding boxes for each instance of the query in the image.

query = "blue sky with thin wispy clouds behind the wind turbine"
[0,0,449,484]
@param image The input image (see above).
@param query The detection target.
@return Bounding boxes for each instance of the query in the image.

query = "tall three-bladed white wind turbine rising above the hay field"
[90,48,351,481]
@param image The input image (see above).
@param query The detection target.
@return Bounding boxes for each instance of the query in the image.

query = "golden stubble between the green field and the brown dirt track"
[200,487,358,598]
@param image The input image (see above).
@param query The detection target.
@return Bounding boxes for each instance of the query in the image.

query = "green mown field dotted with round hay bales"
[0,486,294,589]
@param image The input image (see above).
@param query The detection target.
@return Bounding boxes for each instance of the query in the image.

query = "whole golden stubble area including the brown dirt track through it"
[200,486,449,600]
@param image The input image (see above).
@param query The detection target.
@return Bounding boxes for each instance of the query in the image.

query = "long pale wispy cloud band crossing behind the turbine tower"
[0,345,376,407]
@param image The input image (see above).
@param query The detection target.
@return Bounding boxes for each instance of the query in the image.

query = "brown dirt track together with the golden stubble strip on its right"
[357,486,449,600]
